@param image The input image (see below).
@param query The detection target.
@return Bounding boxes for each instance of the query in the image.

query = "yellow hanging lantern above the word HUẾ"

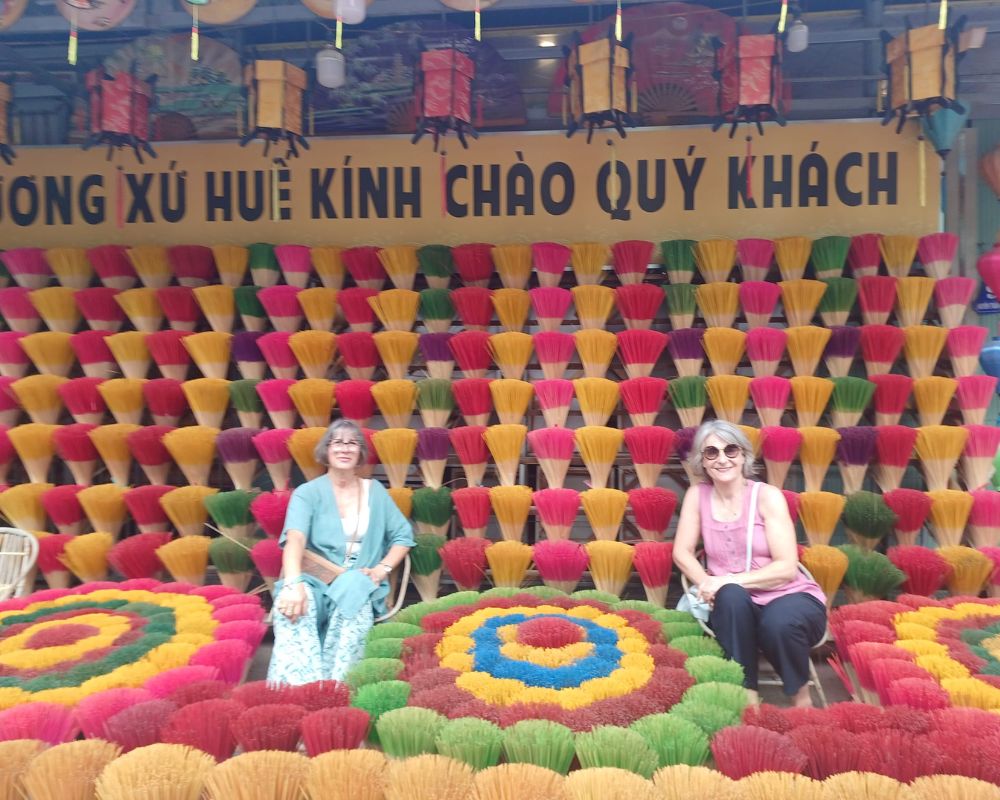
[240,61,309,157]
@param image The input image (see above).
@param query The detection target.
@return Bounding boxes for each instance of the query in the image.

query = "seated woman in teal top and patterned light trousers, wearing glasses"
[267,420,413,685]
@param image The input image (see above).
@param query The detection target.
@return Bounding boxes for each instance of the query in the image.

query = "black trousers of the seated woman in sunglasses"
[708,583,826,696]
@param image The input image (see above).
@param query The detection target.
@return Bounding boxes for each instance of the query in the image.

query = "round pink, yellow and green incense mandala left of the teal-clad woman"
[0,580,263,710]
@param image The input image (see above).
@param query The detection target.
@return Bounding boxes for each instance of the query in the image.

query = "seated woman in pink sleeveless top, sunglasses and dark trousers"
[674,420,826,706]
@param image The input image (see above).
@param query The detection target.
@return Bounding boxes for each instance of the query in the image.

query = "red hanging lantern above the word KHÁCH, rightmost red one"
[712,33,787,137]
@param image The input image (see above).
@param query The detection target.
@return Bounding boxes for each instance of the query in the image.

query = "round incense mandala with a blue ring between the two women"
[348,587,721,730]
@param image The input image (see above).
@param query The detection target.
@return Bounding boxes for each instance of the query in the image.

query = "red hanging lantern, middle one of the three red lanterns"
[411,47,479,152]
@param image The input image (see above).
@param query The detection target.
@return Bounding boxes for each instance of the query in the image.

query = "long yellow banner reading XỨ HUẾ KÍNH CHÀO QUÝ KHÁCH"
[0,120,939,248]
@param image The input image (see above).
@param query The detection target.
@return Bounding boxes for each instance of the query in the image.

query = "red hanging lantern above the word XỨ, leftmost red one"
[83,69,156,164]
